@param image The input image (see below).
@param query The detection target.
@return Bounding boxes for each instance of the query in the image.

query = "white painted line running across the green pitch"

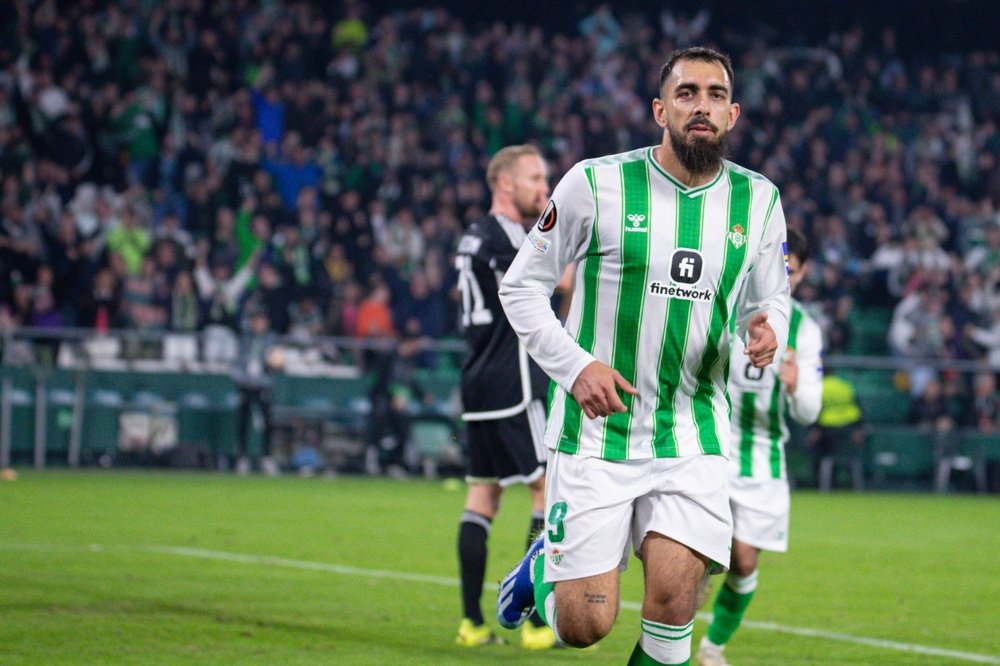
[0,543,1000,666]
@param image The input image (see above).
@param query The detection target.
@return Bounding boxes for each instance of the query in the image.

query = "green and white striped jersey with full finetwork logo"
[500,148,788,460]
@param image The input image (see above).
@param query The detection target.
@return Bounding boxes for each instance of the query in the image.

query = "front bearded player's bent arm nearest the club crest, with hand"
[736,189,790,367]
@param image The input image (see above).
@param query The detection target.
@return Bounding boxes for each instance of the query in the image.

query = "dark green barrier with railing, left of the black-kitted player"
[0,328,464,468]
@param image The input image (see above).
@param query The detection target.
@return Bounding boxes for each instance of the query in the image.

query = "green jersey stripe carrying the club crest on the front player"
[692,170,750,455]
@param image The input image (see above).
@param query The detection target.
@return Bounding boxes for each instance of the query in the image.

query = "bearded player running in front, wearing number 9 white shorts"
[497,48,789,664]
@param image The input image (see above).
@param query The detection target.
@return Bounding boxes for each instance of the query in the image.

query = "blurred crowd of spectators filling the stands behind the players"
[0,0,1000,392]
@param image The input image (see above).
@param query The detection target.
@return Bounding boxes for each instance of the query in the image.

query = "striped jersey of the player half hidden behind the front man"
[729,300,823,479]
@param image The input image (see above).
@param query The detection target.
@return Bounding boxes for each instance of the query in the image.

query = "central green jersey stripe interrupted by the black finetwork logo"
[653,192,705,458]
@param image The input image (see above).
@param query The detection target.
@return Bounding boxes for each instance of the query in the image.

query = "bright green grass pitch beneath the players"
[0,471,1000,666]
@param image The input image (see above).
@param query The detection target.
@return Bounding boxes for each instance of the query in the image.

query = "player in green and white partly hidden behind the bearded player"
[698,229,823,666]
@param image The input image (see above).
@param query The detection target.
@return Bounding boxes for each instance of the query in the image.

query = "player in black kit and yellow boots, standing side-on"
[455,145,555,649]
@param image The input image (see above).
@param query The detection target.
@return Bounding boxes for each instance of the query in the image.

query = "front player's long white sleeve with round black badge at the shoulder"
[500,164,606,400]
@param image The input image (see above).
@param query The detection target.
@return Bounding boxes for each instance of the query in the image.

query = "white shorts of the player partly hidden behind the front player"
[729,477,791,553]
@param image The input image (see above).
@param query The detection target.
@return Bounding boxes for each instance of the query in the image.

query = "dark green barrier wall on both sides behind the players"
[0,328,1000,491]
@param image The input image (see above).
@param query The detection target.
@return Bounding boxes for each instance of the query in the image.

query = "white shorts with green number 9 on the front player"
[545,451,733,581]
